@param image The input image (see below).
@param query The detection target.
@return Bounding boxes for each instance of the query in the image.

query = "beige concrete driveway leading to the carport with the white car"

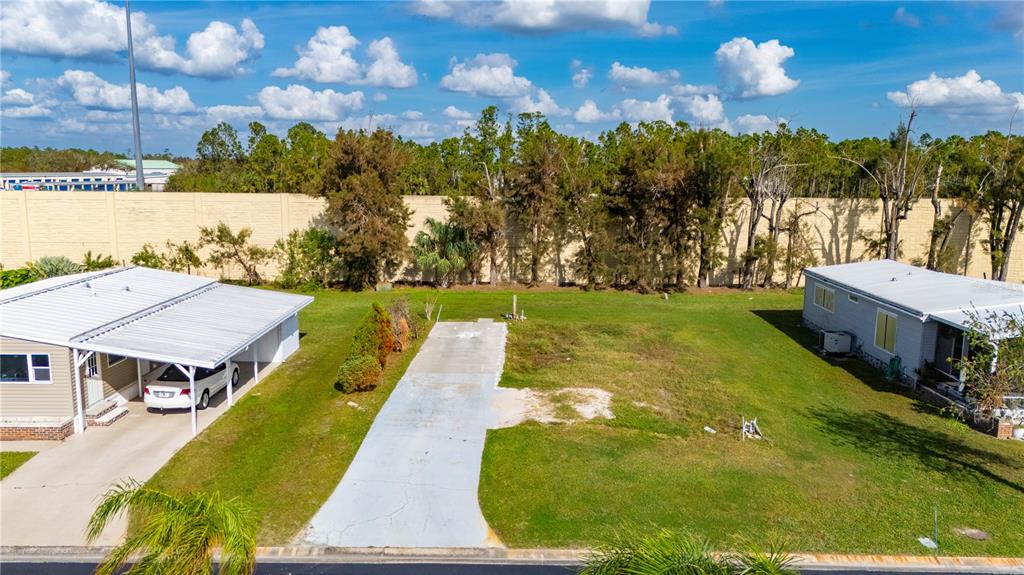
[0,362,274,546]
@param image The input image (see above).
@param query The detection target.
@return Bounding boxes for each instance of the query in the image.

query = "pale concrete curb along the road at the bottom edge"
[0,545,1024,575]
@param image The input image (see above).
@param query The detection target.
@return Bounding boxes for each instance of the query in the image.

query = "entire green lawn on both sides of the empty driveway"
[150,290,1024,556]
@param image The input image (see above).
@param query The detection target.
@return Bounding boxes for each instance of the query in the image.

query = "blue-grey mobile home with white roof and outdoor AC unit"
[804,260,1024,387]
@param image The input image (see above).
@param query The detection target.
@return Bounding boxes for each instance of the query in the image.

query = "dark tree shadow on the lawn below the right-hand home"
[809,407,1024,493]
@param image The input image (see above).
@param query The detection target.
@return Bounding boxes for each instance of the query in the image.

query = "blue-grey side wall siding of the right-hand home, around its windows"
[804,276,935,382]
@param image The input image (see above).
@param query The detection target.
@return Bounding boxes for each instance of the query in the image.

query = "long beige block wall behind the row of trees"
[0,191,1024,281]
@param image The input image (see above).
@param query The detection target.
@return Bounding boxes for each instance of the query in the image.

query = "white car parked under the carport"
[143,360,239,409]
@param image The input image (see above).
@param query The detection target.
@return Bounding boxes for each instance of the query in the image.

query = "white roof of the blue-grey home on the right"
[805,260,1024,328]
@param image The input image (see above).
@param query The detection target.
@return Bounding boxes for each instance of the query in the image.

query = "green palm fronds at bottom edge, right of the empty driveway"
[580,526,797,575]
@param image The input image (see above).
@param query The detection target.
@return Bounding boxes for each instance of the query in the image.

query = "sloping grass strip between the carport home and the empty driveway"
[147,292,426,544]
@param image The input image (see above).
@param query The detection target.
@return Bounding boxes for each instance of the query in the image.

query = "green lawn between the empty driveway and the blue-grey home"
[480,292,1024,556]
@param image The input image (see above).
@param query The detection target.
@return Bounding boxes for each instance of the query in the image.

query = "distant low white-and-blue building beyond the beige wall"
[0,159,179,191]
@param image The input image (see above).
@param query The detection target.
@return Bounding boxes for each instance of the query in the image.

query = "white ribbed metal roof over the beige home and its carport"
[0,267,312,367]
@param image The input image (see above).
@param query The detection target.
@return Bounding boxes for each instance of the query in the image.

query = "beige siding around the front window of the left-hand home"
[0,337,75,426]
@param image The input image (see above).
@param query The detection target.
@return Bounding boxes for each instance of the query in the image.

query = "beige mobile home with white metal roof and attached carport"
[0,267,312,441]
